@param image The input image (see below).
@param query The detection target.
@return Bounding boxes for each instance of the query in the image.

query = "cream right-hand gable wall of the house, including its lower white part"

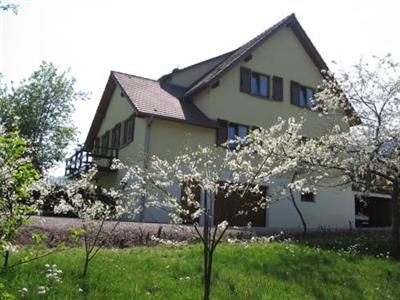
[192,28,355,228]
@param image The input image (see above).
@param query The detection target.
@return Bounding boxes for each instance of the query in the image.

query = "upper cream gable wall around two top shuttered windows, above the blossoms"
[192,28,344,136]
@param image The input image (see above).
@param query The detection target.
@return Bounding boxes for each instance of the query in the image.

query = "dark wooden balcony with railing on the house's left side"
[65,147,118,177]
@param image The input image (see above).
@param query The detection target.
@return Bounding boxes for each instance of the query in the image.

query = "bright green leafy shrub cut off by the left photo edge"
[0,125,38,267]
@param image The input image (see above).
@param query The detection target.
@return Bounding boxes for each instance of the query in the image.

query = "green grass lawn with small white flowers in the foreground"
[0,242,400,299]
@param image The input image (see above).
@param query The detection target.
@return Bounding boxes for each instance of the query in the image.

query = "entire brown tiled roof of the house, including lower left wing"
[85,14,338,148]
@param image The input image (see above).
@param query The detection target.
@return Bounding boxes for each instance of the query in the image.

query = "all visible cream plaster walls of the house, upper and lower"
[90,28,354,228]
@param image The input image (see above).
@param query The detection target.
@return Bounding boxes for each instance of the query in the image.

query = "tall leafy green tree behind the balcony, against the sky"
[0,62,86,172]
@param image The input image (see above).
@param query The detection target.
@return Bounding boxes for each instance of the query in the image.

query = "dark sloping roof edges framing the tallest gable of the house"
[183,14,328,98]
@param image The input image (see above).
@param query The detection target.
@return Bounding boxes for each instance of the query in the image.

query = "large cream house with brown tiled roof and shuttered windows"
[66,14,355,229]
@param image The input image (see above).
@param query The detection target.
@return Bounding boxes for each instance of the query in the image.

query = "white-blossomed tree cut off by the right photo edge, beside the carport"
[313,55,400,257]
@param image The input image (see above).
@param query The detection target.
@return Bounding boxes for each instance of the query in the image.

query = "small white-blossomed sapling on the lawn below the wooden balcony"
[53,167,130,279]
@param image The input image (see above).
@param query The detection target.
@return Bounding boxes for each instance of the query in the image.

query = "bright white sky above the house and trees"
[0,0,400,175]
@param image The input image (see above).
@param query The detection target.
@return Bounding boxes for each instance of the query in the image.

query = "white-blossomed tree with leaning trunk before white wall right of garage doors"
[227,118,338,234]
